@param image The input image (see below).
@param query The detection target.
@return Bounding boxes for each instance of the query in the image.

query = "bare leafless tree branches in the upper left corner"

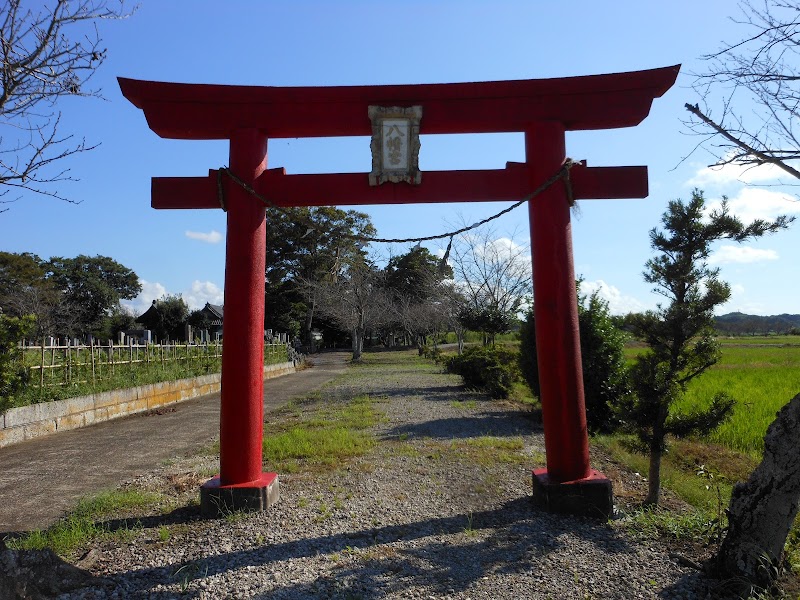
[0,0,129,212]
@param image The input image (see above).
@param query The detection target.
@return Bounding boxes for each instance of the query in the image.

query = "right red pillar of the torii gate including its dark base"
[525,121,614,518]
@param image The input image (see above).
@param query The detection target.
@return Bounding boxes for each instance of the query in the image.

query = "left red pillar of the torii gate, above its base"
[219,129,267,485]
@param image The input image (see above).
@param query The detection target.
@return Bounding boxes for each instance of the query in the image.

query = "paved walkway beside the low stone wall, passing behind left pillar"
[0,352,350,532]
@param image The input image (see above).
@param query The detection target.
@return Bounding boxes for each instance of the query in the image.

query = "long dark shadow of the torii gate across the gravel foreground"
[78,498,648,598]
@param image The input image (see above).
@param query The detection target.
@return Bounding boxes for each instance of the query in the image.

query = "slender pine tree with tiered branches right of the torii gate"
[618,190,793,504]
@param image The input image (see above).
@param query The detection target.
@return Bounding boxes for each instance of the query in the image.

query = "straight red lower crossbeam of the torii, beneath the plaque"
[151,163,648,208]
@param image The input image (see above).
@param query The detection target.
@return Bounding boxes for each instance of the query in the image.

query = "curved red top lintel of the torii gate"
[118,65,680,139]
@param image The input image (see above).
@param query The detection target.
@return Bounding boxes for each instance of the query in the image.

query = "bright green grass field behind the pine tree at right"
[593,336,800,571]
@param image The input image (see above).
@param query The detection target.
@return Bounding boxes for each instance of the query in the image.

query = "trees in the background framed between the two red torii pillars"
[265,207,532,360]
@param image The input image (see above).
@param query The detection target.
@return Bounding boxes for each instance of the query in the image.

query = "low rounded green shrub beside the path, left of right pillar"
[446,346,520,398]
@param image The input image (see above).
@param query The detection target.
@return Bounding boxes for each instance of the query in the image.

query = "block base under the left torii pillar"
[200,473,279,518]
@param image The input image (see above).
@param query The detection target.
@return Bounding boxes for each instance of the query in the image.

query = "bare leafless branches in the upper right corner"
[686,0,800,179]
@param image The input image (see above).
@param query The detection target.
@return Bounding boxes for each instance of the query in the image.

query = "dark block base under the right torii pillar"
[533,469,614,519]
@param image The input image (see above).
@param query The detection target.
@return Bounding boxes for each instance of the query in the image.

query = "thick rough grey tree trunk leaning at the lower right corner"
[712,394,800,588]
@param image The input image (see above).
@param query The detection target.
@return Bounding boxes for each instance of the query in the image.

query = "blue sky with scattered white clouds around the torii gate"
[0,0,800,314]
